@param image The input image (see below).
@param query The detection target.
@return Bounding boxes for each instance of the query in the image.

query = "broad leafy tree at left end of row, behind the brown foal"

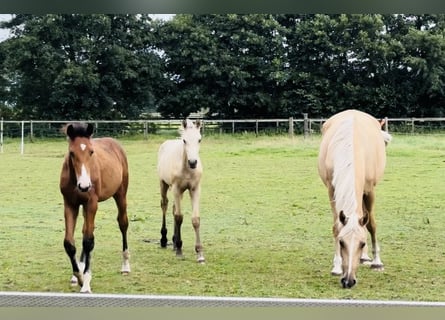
[2,14,165,120]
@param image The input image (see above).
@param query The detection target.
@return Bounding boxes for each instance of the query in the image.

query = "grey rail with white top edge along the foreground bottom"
[0,292,445,308]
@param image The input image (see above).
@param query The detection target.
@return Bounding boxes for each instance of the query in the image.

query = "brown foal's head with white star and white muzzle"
[66,123,94,192]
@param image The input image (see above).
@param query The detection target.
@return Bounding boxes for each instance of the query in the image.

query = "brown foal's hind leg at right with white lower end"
[114,190,131,275]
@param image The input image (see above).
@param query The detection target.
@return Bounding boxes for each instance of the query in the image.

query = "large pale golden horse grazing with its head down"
[318,110,391,288]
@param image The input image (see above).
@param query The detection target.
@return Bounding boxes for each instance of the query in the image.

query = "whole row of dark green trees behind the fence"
[0,14,445,120]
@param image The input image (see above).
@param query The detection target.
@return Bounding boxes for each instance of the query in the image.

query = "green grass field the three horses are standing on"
[0,135,445,301]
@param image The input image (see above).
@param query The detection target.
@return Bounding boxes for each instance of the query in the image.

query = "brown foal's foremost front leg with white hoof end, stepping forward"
[80,198,97,293]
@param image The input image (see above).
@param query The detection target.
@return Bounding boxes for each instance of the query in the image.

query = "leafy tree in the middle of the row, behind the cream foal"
[154,14,284,118]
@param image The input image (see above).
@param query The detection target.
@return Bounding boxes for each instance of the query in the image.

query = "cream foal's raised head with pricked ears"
[181,119,201,169]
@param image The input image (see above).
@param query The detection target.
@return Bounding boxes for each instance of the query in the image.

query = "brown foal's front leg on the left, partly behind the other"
[63,203,83,285]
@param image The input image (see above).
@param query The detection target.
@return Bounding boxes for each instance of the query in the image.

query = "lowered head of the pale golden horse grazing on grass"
[337,211,368,288]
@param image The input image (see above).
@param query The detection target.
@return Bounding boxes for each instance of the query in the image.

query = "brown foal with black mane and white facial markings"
[60,123,130,292]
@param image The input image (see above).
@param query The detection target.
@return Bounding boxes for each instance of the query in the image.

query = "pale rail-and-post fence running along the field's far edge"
[0,114,445,154]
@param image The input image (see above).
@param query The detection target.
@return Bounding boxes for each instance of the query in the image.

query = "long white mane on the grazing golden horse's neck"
[330,115,357,216]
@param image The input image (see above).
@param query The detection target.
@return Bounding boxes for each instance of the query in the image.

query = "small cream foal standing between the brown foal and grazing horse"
[158,119,205,263]
